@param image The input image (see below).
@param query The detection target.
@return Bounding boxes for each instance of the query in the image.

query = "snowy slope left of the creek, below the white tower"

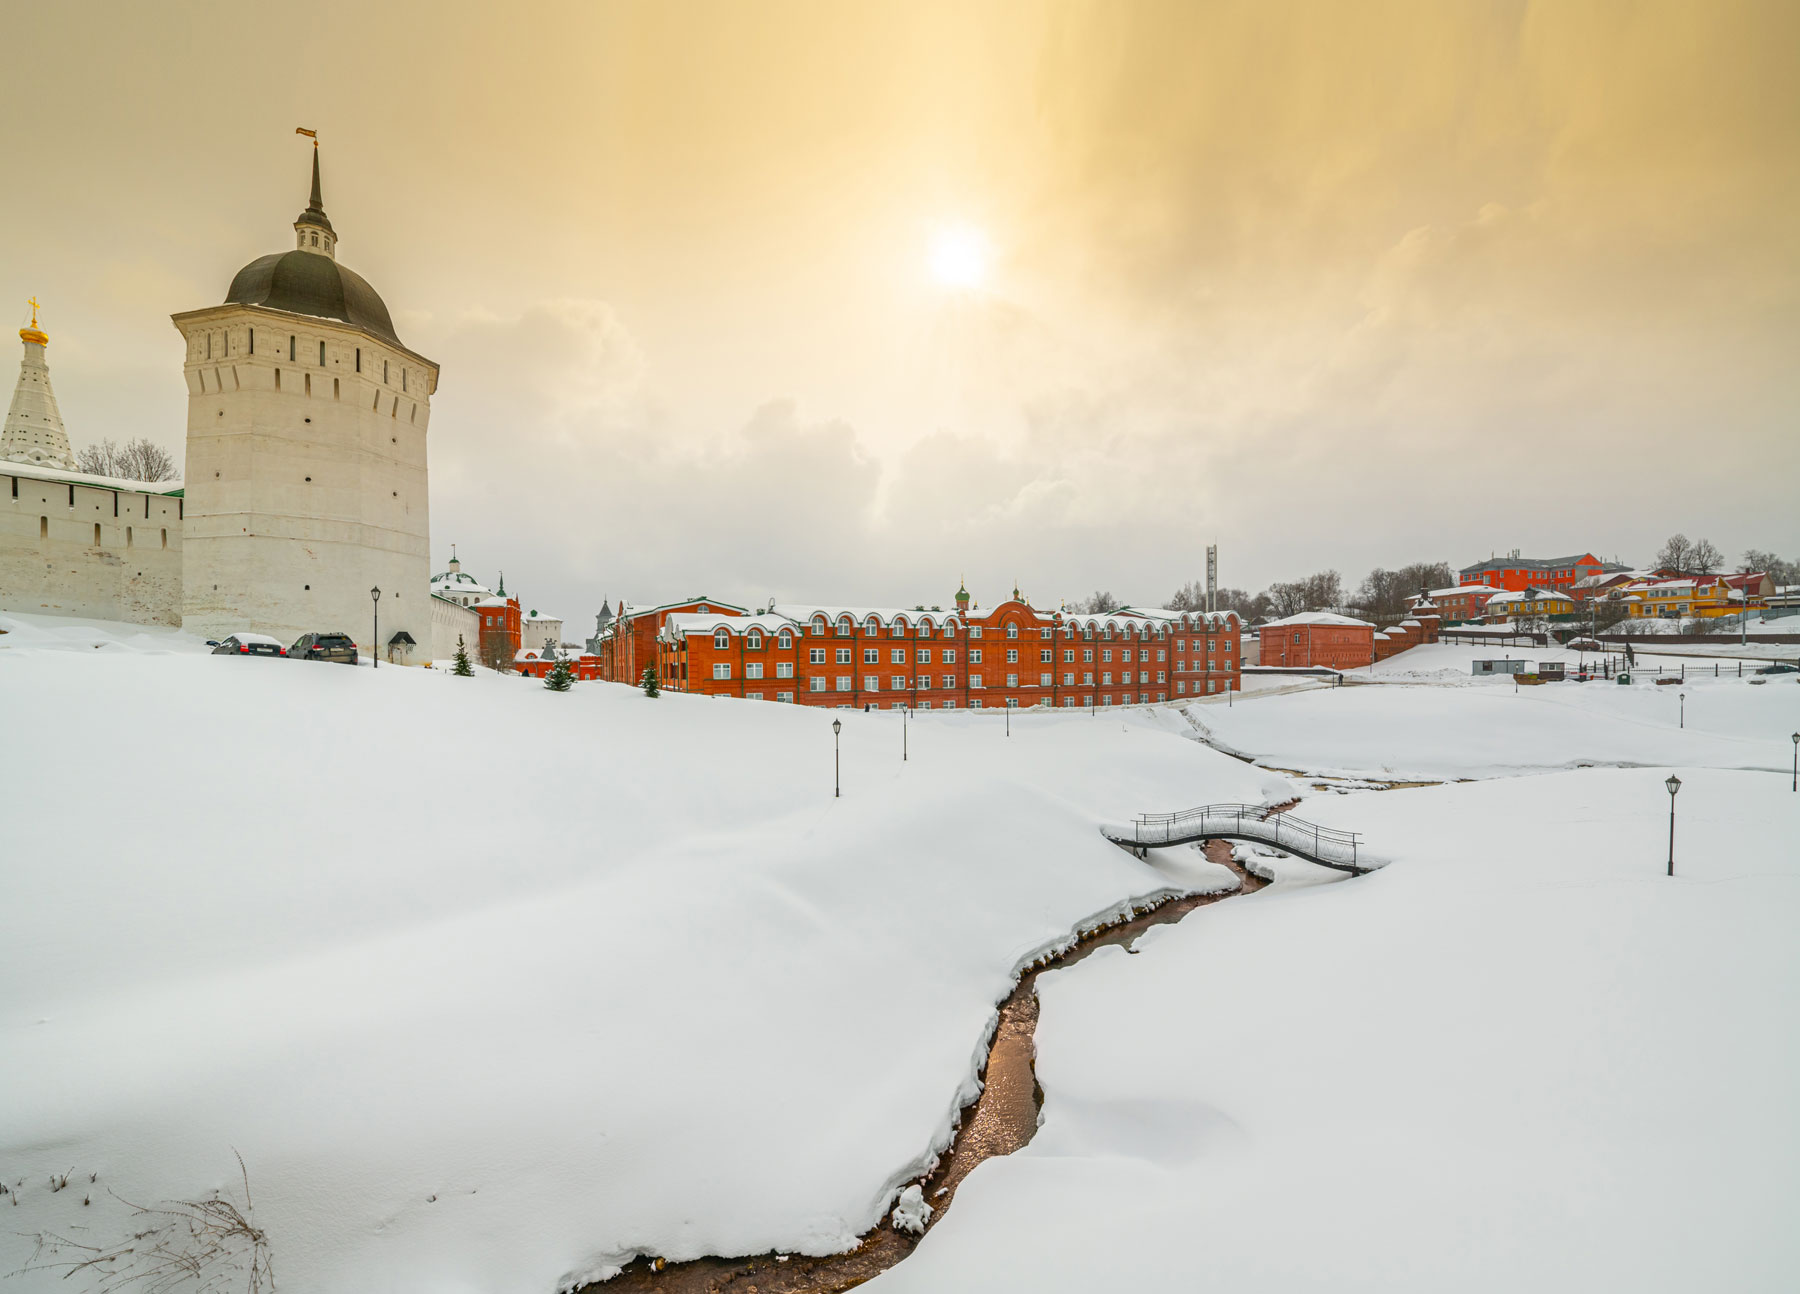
[0,616,1291,1294]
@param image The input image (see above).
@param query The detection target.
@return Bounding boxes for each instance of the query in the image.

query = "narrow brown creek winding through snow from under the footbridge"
[576,838,1289,1294]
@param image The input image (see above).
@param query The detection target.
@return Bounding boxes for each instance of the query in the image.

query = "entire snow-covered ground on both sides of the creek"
[0,617,1800,1294]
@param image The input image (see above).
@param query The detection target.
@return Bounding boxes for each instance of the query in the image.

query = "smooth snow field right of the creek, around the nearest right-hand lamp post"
[866,770,1800,1294]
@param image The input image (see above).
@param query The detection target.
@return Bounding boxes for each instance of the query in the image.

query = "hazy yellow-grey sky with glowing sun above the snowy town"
[0,0,1800,630]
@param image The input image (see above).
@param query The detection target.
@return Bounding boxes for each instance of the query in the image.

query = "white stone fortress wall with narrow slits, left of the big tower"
[0,464,184,625]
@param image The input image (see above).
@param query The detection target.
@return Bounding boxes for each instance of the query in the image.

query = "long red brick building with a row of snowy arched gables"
[657,594,1240,709]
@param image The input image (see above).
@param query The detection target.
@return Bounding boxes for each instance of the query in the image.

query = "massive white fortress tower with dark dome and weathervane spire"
[171,139,437,664]
